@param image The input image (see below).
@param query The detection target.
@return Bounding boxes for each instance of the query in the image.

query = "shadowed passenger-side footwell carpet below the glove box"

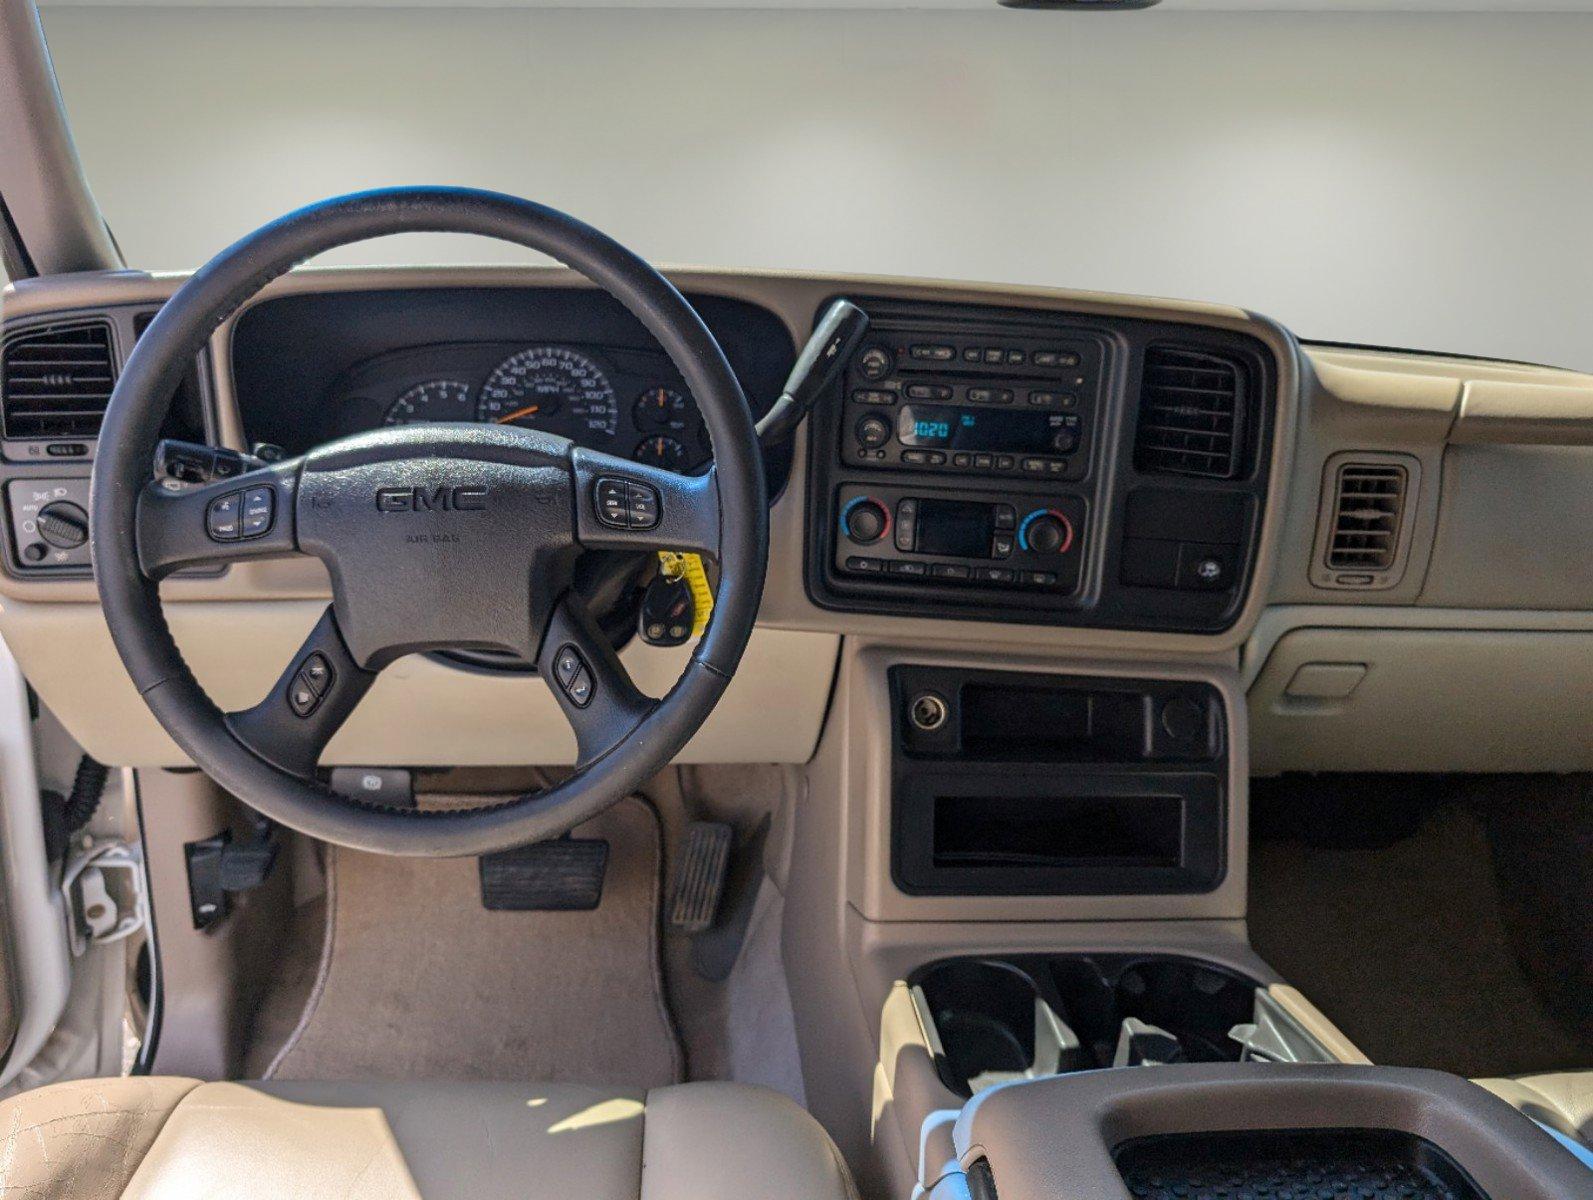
[1249,776,1593,1077]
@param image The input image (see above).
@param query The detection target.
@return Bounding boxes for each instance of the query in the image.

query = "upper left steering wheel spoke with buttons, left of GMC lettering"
[137,461,299,580]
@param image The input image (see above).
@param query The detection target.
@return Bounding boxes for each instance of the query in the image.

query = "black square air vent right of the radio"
[1134,346,1246,480]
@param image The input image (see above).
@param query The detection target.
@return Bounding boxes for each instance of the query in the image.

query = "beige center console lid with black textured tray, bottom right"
[922,1063,1593,1200]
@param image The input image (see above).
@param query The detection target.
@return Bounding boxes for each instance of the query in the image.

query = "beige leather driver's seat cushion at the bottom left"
[0,1079,855,1200]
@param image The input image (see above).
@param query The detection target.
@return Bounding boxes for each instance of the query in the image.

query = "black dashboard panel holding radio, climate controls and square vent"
[808,300,1276,633]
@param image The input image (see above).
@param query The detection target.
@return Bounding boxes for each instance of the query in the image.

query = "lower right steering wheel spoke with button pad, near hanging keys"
[537,593,658,768]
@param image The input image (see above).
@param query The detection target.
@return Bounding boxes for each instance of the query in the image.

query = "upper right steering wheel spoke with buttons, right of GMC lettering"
[572,446,718,556]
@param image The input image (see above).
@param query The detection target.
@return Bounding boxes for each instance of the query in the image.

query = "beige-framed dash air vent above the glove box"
[1311,451,1419,588]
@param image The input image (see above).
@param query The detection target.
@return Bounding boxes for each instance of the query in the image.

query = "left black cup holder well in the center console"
[913,959,1078,1096]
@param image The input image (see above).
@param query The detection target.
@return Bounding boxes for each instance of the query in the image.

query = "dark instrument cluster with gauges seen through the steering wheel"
[328,343,712,473]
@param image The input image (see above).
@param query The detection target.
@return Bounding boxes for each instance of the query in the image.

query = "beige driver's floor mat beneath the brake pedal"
[268,797,683,1087]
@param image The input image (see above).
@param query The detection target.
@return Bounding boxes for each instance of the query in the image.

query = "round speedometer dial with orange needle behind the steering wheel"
[476,346,620,441]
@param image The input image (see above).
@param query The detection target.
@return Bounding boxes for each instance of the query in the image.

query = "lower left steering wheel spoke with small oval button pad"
[226,606,376,779]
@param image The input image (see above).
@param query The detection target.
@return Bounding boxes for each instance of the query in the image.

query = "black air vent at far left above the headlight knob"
[0,320,116,438]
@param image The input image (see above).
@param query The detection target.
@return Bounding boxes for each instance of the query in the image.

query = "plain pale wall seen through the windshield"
[31,6,1593,368]
